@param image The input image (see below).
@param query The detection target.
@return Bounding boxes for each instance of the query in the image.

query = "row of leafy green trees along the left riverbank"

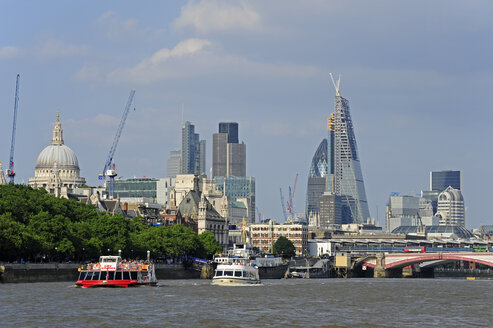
[0,185,221,262]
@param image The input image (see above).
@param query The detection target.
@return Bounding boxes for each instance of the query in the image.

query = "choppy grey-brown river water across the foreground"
[0,279,493,328]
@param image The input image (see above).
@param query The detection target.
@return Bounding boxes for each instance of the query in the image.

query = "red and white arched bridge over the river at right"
[356,252,493,270]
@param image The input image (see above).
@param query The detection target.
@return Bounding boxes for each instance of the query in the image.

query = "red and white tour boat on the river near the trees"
[75,256,157,288]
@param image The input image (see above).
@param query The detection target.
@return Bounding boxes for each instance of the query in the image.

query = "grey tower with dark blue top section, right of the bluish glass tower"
[212,122,246,177]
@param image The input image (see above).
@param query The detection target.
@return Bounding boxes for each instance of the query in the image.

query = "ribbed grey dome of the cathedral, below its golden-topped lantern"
[36,145,79,170]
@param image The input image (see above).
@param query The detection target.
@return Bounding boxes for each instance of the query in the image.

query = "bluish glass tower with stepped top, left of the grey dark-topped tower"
[181,121,205,174]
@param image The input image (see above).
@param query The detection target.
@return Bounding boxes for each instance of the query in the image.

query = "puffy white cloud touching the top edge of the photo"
[173,0,260,34]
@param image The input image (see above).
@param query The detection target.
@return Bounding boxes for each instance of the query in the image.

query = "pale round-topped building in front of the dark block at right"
[437,186,466,227]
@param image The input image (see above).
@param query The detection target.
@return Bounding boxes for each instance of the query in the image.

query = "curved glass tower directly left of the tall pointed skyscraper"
[305,139,328,218]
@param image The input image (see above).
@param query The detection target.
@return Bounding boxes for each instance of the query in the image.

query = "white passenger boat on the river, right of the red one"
[212,258,260,286]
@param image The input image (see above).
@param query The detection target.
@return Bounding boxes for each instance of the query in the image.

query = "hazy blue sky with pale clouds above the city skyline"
[0,0,493,228]
